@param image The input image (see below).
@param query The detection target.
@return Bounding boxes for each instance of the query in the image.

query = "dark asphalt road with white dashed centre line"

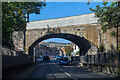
[3,61,117,80]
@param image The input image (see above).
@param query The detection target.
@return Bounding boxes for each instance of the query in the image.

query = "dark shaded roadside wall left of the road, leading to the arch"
[1,48,33,70]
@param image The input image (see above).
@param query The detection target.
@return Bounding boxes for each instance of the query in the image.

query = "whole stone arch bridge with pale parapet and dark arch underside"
[12,13,116,55]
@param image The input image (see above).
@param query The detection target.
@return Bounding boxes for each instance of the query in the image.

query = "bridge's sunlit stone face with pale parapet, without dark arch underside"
[11,13,120,54]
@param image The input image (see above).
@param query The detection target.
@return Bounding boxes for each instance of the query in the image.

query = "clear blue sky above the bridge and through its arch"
[30,2,110,43]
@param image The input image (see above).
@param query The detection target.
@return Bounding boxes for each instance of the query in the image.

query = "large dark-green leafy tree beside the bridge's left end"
[2,2,46,47]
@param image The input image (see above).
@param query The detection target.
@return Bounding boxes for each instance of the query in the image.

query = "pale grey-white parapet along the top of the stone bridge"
[27,13,98,29]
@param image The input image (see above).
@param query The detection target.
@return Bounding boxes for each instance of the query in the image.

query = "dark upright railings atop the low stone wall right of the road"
[81,52,118,64]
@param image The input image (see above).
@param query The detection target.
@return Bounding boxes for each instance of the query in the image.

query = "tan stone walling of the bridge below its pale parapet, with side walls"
[13,24,120,54]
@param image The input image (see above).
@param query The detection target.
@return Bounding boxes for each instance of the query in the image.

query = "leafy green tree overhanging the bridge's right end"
[90,1,120,50]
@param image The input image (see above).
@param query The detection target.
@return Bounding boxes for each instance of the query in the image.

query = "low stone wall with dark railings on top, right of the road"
[80,53,120,76]
